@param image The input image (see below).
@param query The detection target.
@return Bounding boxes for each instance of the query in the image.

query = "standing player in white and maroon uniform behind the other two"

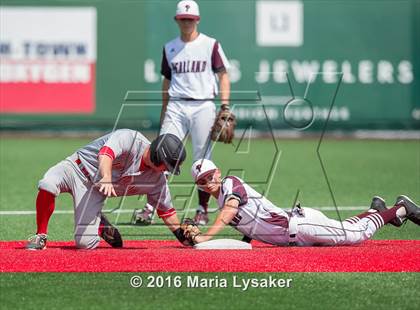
[133,0,230,225]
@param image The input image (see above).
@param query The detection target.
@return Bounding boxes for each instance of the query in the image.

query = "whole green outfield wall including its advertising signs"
[0,0,420,131]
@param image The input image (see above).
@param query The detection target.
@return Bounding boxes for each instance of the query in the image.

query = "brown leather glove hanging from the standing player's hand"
[211,104,236,143]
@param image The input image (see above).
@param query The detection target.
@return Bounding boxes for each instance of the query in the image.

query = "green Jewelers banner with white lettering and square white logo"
[143,0,420,131]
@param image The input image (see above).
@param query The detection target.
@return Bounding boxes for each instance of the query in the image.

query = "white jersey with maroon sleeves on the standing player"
[161,33,228,100]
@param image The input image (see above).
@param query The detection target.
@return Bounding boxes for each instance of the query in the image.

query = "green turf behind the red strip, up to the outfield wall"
[0,138,420,240]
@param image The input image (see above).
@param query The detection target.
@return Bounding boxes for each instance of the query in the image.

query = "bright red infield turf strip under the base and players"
[0,240,420,272]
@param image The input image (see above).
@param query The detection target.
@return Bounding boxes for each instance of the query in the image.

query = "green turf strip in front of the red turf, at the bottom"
[0,273,420,310]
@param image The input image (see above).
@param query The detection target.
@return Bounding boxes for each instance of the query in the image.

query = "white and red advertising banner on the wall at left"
[0,7,97,114]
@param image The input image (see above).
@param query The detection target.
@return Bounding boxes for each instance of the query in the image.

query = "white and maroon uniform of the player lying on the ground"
[217,176,389,246]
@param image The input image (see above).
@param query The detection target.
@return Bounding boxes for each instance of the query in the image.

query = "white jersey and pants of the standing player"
[160,33,228,160]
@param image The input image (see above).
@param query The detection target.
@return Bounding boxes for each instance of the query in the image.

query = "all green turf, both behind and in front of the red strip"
[0,138,420,310]
